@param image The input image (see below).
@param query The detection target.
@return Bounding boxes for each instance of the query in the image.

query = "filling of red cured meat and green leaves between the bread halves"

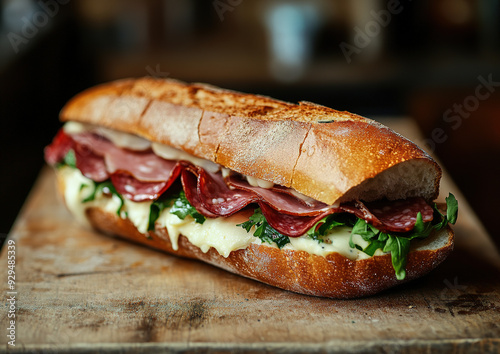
[45,122,457,279]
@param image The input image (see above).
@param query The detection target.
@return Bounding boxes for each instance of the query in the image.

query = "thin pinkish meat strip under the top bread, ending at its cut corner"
[226,176,331,216]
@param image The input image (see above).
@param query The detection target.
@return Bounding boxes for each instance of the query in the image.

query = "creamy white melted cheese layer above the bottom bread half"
[59,167,383,260]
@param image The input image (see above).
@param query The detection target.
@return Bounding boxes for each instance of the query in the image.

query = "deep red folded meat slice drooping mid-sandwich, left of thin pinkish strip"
[198,168,259,216]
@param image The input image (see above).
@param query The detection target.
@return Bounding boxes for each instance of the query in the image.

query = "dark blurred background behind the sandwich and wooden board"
[0,0,500,246]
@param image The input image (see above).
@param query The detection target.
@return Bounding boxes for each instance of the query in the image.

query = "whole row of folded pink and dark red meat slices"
[45,130,434,237]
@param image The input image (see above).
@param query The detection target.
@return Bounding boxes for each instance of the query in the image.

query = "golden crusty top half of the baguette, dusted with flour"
[61,77,441,204]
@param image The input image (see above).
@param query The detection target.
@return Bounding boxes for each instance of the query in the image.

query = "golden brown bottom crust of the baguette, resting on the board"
[86,207,453,299]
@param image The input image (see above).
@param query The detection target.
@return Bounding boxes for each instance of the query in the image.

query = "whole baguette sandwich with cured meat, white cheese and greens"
[45,77,458,298]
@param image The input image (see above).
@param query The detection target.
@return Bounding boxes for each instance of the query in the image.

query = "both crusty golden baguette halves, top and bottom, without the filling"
[46,78,454,298]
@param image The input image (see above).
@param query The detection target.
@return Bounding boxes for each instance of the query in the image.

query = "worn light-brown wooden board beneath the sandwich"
[0,119,500,353]
